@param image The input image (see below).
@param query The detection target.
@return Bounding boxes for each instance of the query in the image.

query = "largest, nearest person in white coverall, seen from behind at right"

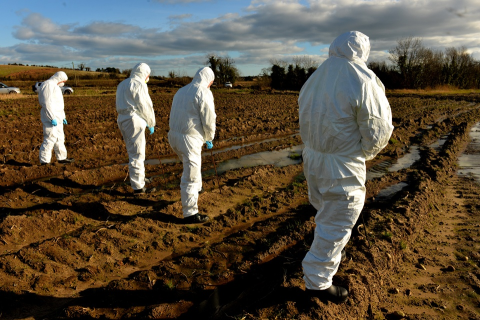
[298,31,393,303]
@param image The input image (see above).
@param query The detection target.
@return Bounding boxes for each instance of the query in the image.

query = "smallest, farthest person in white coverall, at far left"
[38,71,74,165]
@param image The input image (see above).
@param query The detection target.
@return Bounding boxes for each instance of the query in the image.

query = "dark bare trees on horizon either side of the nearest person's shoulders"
[259,37,480,91]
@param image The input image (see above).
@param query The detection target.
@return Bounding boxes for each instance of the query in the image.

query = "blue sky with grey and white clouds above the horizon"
[0,0,480,76]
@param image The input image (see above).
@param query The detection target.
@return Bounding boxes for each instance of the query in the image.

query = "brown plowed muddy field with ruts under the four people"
[0,88,480,319]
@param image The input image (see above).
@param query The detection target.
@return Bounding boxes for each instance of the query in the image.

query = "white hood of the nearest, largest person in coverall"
[328,31,370,63]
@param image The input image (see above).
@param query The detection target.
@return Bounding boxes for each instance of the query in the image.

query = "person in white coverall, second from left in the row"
[116,63,155,194]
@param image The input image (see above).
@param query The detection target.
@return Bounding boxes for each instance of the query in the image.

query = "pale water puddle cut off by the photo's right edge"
[458,122,480,182]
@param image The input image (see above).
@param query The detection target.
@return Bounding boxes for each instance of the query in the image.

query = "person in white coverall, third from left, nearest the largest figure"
[168,67,216,224]
